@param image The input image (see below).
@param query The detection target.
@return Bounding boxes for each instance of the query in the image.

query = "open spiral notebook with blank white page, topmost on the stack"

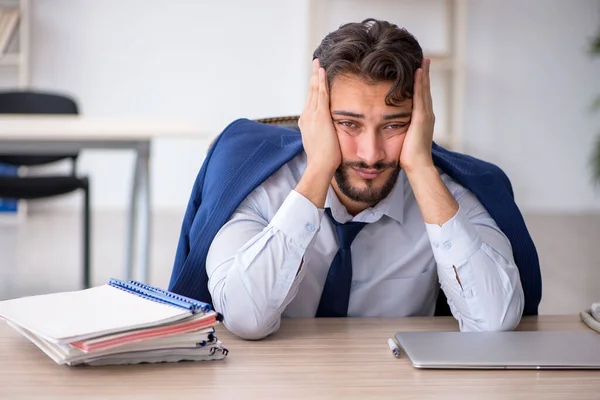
[0,279,210,344]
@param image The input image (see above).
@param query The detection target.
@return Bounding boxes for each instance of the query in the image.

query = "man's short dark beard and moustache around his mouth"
[334,161,400,205]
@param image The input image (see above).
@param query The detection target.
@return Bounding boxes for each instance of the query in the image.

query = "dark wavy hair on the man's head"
[313,18,423,105]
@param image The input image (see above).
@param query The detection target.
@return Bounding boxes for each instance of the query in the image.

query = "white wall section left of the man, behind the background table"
[26,0,310,209]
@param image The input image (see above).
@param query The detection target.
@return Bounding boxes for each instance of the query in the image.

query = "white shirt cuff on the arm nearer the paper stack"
[269,190,325,249]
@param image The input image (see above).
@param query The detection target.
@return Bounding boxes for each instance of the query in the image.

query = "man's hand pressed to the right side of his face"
[400,58,435,173]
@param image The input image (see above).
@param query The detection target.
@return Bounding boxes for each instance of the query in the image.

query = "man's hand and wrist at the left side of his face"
[296,59,342,208]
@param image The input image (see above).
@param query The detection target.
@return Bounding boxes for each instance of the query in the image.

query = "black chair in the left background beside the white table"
[0,91,90,288]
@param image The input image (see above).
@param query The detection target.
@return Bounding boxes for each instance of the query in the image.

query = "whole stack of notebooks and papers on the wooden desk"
[0,279,228,365]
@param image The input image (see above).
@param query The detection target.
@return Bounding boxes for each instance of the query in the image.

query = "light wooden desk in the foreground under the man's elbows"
[0,316,600,400]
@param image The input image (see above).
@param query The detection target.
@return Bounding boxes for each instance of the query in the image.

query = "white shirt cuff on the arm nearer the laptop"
[425,207,483,267]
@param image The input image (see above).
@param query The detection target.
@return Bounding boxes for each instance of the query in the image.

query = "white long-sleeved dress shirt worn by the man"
[206,153,524,339]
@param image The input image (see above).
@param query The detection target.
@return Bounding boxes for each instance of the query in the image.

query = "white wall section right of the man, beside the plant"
[464,0,600,212]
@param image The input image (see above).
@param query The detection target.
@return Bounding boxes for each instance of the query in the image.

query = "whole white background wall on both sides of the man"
[5,0,600,212]
